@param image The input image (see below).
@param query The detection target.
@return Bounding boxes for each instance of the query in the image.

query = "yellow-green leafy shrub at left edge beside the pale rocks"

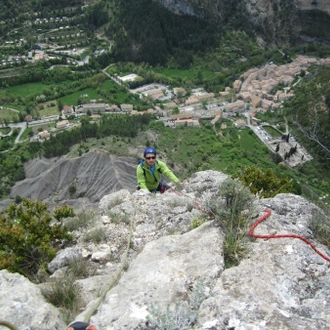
[0,198,74,277]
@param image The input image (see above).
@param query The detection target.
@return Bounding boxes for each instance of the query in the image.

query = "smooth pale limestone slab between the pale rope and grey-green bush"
[91,223,224,329]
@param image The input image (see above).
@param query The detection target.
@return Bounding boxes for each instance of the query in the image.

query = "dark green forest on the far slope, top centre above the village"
[106,0,221,68]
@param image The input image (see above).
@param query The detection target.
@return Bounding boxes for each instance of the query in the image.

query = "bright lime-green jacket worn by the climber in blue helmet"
[136,160,180,190]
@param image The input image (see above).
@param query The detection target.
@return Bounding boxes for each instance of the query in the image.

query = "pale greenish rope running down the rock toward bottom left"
[66,205,136,330]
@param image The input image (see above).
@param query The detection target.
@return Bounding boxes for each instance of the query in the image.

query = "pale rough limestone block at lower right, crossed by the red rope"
[197,194,330,330]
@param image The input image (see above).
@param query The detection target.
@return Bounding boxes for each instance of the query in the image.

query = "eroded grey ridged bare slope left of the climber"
[11,151,137,204]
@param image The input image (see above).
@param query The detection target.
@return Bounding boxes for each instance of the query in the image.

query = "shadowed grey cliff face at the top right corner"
[158,0,330,45]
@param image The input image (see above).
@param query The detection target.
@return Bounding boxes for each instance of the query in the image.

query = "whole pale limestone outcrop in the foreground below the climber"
[0,171,330,330]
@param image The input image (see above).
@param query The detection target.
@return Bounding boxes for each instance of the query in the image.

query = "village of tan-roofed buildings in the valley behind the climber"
[2,56,330,167]
